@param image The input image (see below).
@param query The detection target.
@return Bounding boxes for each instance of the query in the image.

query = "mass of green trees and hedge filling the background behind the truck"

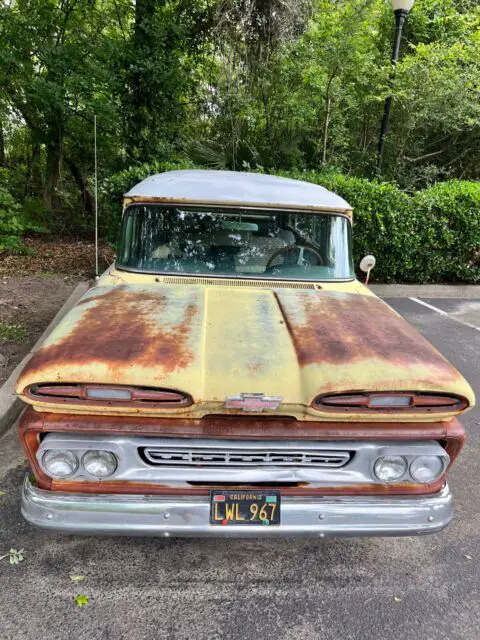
[0,0,480,282]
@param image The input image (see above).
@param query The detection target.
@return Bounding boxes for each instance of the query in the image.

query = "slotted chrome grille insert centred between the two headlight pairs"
[139,446,351,469]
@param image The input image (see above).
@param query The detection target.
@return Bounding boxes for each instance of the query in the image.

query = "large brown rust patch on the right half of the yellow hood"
[275,292,459,382]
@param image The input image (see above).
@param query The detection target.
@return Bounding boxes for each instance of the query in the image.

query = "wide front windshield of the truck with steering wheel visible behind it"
[117,205,353,280]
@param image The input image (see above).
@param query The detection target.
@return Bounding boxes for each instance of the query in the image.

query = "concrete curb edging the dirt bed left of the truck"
[0,282,90,436]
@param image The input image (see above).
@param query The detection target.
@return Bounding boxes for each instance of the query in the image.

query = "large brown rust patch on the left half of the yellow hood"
[19,286,199,375]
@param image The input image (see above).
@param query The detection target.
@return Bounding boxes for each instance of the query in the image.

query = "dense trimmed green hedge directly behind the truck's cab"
[102,162,480,283]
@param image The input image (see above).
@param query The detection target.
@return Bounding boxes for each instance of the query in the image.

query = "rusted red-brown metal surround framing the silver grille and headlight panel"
[20,408,465,496]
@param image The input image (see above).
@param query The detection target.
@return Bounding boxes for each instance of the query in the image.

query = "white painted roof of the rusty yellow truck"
[125,170,352,212]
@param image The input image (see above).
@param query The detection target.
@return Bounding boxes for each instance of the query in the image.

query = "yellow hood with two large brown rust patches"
[17,283,474,420]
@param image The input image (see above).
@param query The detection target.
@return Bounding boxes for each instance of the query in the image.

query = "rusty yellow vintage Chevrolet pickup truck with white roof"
[17,171,474,538]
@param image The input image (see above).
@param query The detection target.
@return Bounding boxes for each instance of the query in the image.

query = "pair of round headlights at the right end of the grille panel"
[373,455,448,484]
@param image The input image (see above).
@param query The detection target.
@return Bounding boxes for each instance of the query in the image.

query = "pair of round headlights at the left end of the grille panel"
[42,449,118,480]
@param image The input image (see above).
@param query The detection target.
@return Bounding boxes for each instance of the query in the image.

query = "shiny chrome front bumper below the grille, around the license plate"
[22,476,453,538]
